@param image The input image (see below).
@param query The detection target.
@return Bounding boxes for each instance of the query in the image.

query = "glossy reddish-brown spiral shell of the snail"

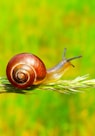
[6,53,46,89]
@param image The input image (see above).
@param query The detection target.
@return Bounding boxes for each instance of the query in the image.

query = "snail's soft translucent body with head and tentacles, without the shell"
[44,48,82,83]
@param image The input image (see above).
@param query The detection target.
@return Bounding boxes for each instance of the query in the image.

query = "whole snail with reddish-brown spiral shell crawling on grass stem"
[6,48,81,89]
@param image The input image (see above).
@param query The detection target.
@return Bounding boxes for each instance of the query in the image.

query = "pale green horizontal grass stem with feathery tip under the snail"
[0,75,95,94]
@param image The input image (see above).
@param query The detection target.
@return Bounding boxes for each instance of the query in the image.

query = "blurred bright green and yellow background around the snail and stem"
[0,0,95,136]
